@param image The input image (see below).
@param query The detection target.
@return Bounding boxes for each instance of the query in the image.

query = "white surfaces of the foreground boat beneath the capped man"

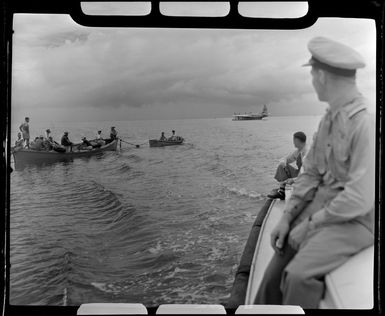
[244,190,374,309]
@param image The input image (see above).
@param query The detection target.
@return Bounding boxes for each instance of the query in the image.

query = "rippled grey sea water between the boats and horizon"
[10,116,320,306]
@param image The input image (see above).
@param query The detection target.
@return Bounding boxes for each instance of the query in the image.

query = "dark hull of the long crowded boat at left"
[13,140,118,167]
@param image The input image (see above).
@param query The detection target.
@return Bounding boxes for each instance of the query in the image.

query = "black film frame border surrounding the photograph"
[0,0,385,315]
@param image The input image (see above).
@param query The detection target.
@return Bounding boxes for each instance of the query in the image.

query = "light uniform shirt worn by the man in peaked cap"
[285,94,375,231]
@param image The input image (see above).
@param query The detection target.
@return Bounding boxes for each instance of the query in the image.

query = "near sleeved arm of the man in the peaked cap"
[312,115,375,226]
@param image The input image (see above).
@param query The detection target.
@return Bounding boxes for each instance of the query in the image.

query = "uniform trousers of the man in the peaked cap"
[255,186,374,308]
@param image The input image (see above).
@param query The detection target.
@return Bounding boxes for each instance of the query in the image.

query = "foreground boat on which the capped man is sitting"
[228,190,374,309]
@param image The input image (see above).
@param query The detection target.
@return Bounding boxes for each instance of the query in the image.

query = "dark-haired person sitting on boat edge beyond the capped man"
[267,132,307,200]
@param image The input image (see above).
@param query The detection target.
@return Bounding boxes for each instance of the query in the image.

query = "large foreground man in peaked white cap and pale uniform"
[255,37,375,309]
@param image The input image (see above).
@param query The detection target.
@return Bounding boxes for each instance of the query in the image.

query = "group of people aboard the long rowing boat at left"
[14,117,118,152]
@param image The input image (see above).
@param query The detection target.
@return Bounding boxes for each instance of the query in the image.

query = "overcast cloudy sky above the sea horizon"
[12,4,376,124]
